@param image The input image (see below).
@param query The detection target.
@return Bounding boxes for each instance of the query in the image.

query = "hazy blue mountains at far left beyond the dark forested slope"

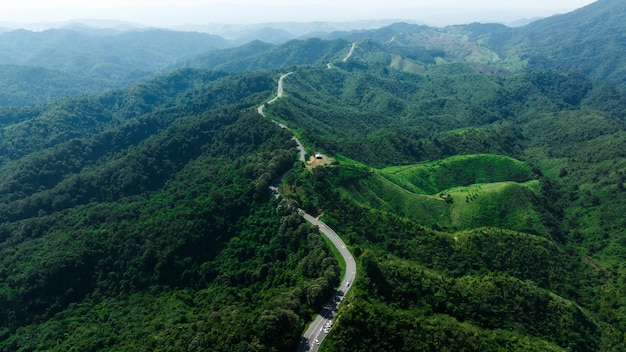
[0,28,230,106]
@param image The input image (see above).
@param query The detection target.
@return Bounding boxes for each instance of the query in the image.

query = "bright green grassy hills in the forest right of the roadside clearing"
[334,155,547,235]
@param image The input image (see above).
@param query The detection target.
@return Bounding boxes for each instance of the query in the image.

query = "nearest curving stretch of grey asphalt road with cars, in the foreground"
[298,209,356,352]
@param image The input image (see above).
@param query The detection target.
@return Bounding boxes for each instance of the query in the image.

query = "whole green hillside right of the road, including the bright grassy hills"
[267,28,626,351]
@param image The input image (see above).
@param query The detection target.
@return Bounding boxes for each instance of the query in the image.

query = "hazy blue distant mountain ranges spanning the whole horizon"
[0,0,626,105]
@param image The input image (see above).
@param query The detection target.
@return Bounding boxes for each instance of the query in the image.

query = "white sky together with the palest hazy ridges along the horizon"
[0,0,592,56]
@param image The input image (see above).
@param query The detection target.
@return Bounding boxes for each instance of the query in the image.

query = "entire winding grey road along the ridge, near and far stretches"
[257,73,356,352]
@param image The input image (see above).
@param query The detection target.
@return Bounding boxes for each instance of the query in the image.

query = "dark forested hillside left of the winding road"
[0,70,339,351]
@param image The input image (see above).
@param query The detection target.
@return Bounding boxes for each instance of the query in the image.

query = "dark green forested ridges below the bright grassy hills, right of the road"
[284,162,604,351]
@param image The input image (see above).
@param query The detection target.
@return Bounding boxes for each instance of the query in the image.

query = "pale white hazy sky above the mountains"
[0,0,594,26]
